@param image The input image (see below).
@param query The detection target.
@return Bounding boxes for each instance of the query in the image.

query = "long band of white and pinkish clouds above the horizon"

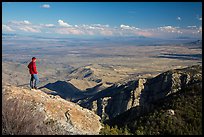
[2,20,202,38]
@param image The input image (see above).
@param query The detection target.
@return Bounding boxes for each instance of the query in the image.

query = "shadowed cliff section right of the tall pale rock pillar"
[140,65,202,104]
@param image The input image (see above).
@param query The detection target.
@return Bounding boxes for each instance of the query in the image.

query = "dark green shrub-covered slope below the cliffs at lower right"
[101,82,202,135]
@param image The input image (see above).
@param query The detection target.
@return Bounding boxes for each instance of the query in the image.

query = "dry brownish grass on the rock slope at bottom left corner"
[2,94,54,135]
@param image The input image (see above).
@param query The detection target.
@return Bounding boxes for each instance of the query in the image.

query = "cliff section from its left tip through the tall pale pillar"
[78,79,146,120]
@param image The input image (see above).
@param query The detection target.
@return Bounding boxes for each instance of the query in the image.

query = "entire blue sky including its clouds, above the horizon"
[2,2,202,38]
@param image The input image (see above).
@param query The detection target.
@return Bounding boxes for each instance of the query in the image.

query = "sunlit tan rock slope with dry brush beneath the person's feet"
[2,85,101,135]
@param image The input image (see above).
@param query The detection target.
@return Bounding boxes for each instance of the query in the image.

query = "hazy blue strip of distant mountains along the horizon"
[2,33,202,45]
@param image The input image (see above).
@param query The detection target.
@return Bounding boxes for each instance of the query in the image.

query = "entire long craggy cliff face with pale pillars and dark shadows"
[79,66,202,119]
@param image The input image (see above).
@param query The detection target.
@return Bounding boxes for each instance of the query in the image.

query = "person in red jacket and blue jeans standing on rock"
[28,57,39,89]
